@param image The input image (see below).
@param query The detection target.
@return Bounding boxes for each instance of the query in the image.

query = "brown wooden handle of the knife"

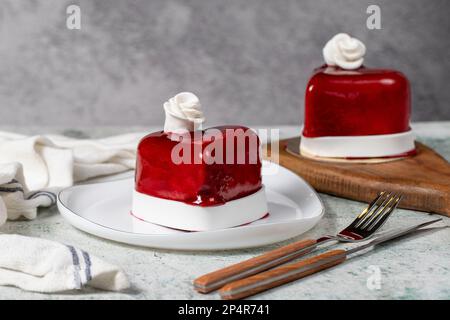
[219,250,346,300]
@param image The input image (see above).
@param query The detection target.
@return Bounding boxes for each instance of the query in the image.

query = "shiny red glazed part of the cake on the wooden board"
[303,65,411,138]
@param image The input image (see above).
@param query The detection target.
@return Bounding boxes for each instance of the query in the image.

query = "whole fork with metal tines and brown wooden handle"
[194,191,402,293]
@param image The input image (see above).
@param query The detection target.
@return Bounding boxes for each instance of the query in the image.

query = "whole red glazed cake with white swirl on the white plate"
[132,93,268,231]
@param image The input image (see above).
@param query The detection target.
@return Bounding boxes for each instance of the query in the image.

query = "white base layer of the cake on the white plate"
[131,186,268,231]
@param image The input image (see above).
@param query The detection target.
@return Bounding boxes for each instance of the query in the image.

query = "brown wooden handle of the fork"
[194,239,317,293]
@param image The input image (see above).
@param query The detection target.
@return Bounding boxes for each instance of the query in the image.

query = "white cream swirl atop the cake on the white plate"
[164,92,205,132]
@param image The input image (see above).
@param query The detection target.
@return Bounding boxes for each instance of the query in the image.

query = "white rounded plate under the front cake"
[58,163,324,250]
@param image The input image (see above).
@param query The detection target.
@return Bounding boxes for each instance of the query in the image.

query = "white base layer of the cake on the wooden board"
[300,130,415,158]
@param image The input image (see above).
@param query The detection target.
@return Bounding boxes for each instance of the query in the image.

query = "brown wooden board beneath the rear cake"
[267,138,450,216]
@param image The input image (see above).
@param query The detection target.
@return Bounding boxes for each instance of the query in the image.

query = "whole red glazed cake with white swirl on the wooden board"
[300,34,415,160]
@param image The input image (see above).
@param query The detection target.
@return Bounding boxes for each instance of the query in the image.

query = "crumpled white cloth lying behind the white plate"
[0,132,144,226]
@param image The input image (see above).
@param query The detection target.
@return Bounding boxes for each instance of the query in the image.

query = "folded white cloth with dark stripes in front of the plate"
[0,234,130,293]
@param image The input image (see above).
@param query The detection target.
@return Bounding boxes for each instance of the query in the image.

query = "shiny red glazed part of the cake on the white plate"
[135,126,262,207]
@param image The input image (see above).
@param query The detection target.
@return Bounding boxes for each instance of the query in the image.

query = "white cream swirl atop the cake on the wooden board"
[322,33,366,70]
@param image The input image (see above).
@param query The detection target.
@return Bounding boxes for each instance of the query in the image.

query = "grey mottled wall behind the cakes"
[0,0,450,126]
